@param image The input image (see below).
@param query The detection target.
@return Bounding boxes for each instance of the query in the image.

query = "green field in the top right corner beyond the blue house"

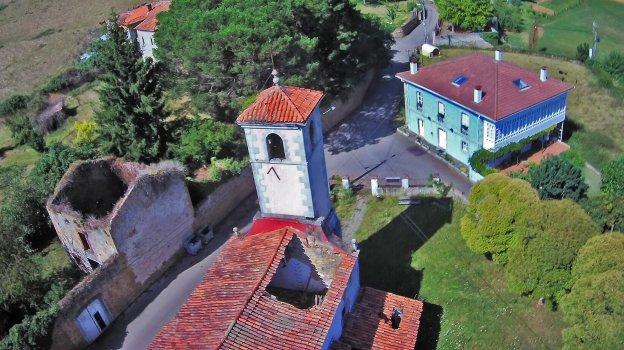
[508,0,624,58]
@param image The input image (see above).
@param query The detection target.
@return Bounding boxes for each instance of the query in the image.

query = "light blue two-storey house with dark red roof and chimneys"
[397,51,572,181]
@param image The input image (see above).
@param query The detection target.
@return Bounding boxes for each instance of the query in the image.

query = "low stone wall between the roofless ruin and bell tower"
[193,167,255,231]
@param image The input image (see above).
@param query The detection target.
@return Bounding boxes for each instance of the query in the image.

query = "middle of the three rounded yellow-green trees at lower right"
[506,199,597,300]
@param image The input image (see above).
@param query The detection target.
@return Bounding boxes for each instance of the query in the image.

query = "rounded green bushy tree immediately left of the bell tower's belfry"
[171,118,238,169]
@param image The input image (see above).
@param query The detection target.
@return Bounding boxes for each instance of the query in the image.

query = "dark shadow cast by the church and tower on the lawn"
[359,198,453,349]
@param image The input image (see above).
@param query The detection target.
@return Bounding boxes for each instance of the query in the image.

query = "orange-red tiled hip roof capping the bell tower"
[236,86,323,124]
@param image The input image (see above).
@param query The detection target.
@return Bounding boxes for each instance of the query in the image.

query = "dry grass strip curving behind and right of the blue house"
[425,49,624,169]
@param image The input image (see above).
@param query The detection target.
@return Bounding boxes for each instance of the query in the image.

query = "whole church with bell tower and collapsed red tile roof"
[149,75,423,350]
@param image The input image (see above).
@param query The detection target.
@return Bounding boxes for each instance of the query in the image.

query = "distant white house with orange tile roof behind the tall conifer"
[118,0,171,58]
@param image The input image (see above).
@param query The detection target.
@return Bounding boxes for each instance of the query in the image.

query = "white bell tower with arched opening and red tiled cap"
[236,71,332,219]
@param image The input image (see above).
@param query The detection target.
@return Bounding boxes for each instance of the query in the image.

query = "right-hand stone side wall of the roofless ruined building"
[110,171,194,284]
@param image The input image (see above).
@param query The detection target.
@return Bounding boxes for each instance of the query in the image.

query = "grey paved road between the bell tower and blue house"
[325,5,472,194]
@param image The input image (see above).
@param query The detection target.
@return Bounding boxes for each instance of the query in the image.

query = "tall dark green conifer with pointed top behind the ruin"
[95,13,168,162]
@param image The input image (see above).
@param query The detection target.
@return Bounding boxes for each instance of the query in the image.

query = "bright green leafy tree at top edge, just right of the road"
[436,0,494,31]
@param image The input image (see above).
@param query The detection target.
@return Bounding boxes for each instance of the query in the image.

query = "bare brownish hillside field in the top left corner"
[0,0,143,99]
